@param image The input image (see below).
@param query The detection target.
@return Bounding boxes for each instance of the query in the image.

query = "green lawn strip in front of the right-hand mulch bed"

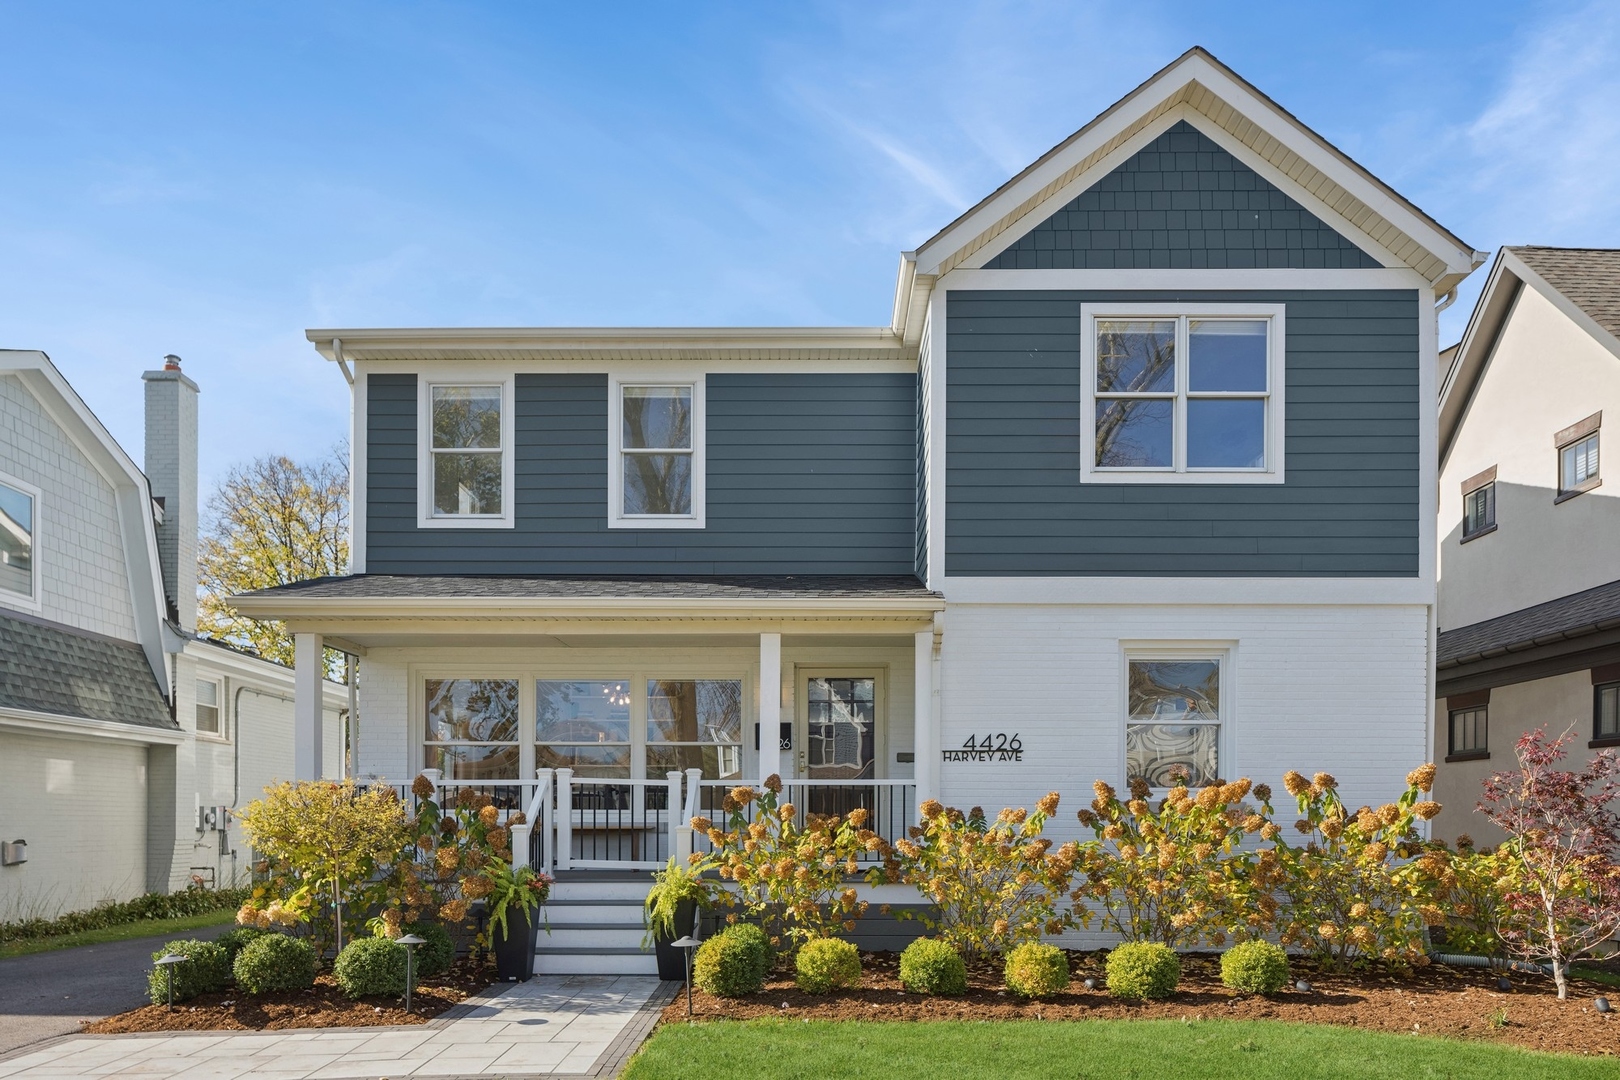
[622,1020,1617,1080]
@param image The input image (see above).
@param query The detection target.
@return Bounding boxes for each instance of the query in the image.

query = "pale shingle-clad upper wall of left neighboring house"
[0,376,136,641]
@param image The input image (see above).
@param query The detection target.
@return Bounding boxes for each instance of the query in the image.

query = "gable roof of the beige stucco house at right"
[1440,246,1620,465]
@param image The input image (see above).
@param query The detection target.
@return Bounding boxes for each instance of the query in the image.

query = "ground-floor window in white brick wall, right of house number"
[1123,644,1233,790]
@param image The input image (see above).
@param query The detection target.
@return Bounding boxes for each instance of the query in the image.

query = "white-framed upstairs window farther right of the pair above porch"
[608,376,706,529]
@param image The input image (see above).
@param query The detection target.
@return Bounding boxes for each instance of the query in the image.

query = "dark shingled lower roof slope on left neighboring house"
[0,615,178,730]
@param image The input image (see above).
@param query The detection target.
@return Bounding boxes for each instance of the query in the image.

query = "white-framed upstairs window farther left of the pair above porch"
[416,379,515,528]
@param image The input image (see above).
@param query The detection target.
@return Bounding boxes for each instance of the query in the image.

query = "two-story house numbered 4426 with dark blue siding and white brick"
[240,49,1486,970]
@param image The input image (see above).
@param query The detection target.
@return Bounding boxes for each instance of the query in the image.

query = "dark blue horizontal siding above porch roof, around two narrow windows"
[366,372,917,575]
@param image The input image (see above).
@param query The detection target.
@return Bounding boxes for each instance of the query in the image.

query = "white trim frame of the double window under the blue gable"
[1079,301,1288,484]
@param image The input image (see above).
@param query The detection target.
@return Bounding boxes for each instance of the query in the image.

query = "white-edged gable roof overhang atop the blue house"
[896,47,1486,330]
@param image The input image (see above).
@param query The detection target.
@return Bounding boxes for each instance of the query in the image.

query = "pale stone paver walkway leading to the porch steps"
[0,975,674,1080]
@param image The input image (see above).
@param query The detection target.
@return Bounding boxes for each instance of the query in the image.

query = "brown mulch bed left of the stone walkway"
[84,959,496,1035]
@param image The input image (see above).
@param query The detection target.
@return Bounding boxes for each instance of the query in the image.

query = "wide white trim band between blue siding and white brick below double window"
[935,576,1435,607]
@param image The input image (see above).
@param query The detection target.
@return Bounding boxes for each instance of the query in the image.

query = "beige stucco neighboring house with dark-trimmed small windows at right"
[1434,248,1620,842]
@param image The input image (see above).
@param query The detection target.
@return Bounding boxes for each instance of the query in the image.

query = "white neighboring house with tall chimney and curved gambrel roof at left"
[0,351,347,920]
